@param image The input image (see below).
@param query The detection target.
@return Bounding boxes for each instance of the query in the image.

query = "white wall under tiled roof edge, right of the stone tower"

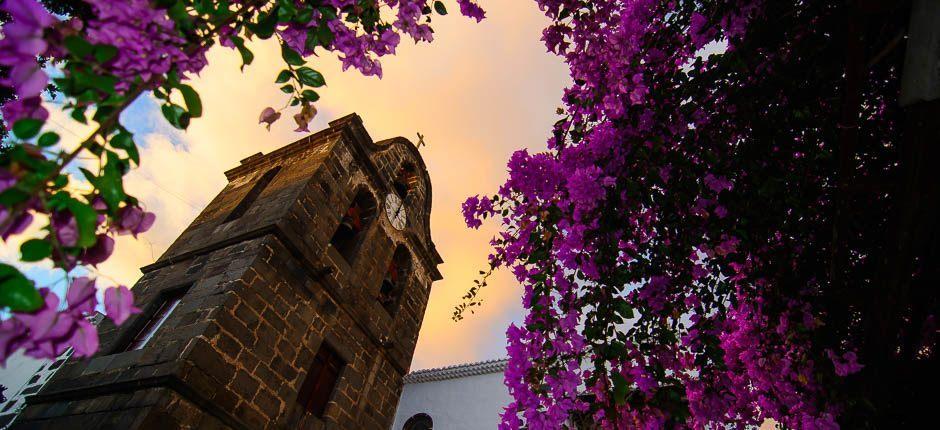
[392,372,512,430]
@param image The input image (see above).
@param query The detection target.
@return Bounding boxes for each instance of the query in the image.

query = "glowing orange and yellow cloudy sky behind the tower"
[25,0,569,369]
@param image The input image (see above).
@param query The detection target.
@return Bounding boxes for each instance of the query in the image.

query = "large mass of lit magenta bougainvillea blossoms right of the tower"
[463,0,862,429]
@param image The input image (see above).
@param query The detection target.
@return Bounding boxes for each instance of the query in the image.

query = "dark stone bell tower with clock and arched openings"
[13,114,441,430]
